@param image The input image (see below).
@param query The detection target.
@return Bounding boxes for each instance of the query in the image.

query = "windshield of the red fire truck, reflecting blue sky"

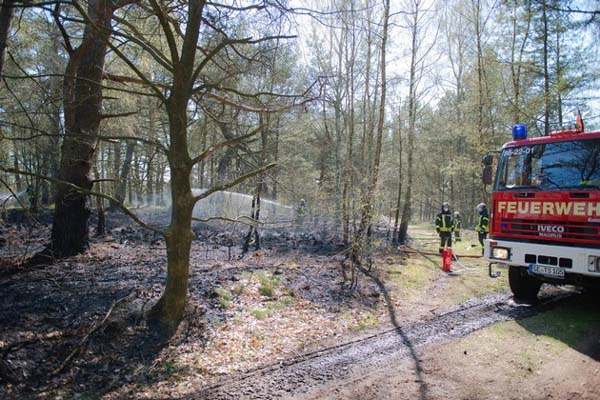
[495,139,600,190]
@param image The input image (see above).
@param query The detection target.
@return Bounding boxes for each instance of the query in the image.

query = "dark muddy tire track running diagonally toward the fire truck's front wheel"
[191,290,574,400]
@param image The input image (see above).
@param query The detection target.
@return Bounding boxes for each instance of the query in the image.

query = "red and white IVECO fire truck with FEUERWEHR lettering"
[484,122,600,299]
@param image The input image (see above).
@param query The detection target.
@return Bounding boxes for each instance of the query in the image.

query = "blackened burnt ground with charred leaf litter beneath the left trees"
[0,208,375,398]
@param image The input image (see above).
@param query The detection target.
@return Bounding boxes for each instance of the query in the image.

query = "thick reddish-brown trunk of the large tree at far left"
[49,0,119,257]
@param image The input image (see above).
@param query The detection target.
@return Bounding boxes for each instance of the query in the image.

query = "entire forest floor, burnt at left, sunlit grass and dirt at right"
[0,211,600,400]
